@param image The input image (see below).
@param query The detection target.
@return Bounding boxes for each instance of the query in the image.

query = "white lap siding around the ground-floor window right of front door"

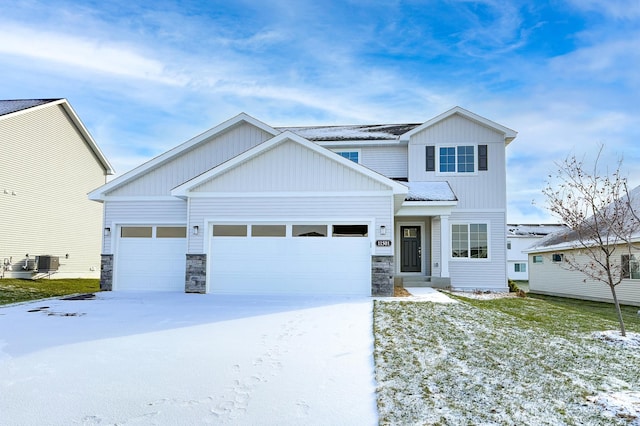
[448,211,507,290]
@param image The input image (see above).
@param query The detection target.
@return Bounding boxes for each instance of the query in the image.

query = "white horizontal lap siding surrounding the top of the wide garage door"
[188,196,393,256]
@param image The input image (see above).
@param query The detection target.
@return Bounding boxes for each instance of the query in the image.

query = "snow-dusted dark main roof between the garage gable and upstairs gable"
[276,124,420,142]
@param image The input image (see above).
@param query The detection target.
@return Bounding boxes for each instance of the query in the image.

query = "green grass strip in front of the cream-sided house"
[0,278,100,305]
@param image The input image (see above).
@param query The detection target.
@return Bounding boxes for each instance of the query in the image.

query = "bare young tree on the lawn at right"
[543,146,640,336]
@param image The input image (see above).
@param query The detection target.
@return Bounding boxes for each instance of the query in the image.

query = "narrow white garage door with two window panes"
[114,225,187,291]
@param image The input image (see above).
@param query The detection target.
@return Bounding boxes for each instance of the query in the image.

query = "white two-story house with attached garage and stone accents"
[89,107,516,295]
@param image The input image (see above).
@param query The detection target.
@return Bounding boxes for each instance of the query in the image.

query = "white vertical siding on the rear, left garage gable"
[107,123,272,196]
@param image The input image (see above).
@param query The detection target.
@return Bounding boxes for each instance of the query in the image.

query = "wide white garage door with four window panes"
[209,224,371,296]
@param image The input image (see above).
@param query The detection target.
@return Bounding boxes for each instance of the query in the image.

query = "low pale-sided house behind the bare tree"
[525,187,640,306]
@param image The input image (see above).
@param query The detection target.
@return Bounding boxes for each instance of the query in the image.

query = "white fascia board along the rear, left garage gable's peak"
[89,112,280,201]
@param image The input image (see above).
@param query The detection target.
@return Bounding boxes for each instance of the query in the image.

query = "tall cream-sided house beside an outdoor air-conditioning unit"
[0,99,113,278]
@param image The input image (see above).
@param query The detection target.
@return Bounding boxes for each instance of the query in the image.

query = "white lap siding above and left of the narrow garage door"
[103,199,187,254]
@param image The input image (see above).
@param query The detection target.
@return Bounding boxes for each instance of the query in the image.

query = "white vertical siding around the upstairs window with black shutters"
[408,115,506,209]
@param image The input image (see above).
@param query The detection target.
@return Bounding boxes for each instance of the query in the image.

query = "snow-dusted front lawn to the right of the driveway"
[374,299,640,425]
